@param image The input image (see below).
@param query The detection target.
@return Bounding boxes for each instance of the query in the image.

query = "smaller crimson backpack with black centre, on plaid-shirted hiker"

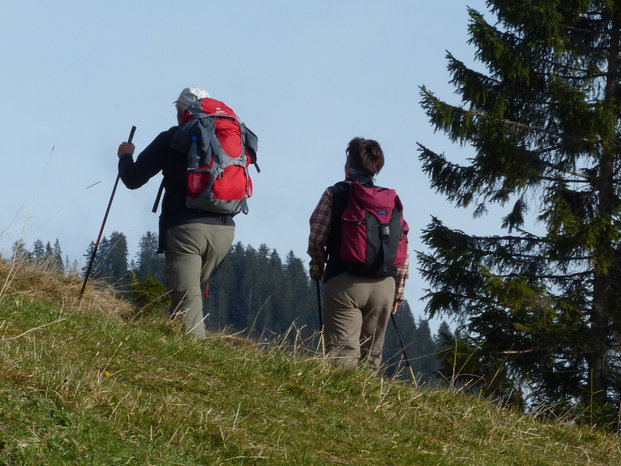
[338,181,409,277]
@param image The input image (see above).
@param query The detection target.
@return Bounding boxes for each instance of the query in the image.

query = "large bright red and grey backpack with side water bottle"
[162,98,260,214]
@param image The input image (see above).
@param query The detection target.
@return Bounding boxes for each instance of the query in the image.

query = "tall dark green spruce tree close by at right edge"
[419,0,621,425]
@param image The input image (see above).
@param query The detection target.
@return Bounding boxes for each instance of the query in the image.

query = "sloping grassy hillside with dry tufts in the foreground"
[0,256,621,465]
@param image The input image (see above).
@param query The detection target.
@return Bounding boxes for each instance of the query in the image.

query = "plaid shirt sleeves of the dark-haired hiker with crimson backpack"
[306,188,410,302]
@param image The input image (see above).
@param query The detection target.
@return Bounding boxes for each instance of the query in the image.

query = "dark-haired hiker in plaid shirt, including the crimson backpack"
[307,138,409,369]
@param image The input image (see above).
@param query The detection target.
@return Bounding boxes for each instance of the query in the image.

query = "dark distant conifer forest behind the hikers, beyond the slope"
[7,231,451,383]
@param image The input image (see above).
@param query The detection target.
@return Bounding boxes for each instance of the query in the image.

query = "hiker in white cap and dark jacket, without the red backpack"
[117,88,247,338]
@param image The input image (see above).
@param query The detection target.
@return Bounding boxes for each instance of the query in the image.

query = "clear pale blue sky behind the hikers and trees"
[0,0,492,324]
